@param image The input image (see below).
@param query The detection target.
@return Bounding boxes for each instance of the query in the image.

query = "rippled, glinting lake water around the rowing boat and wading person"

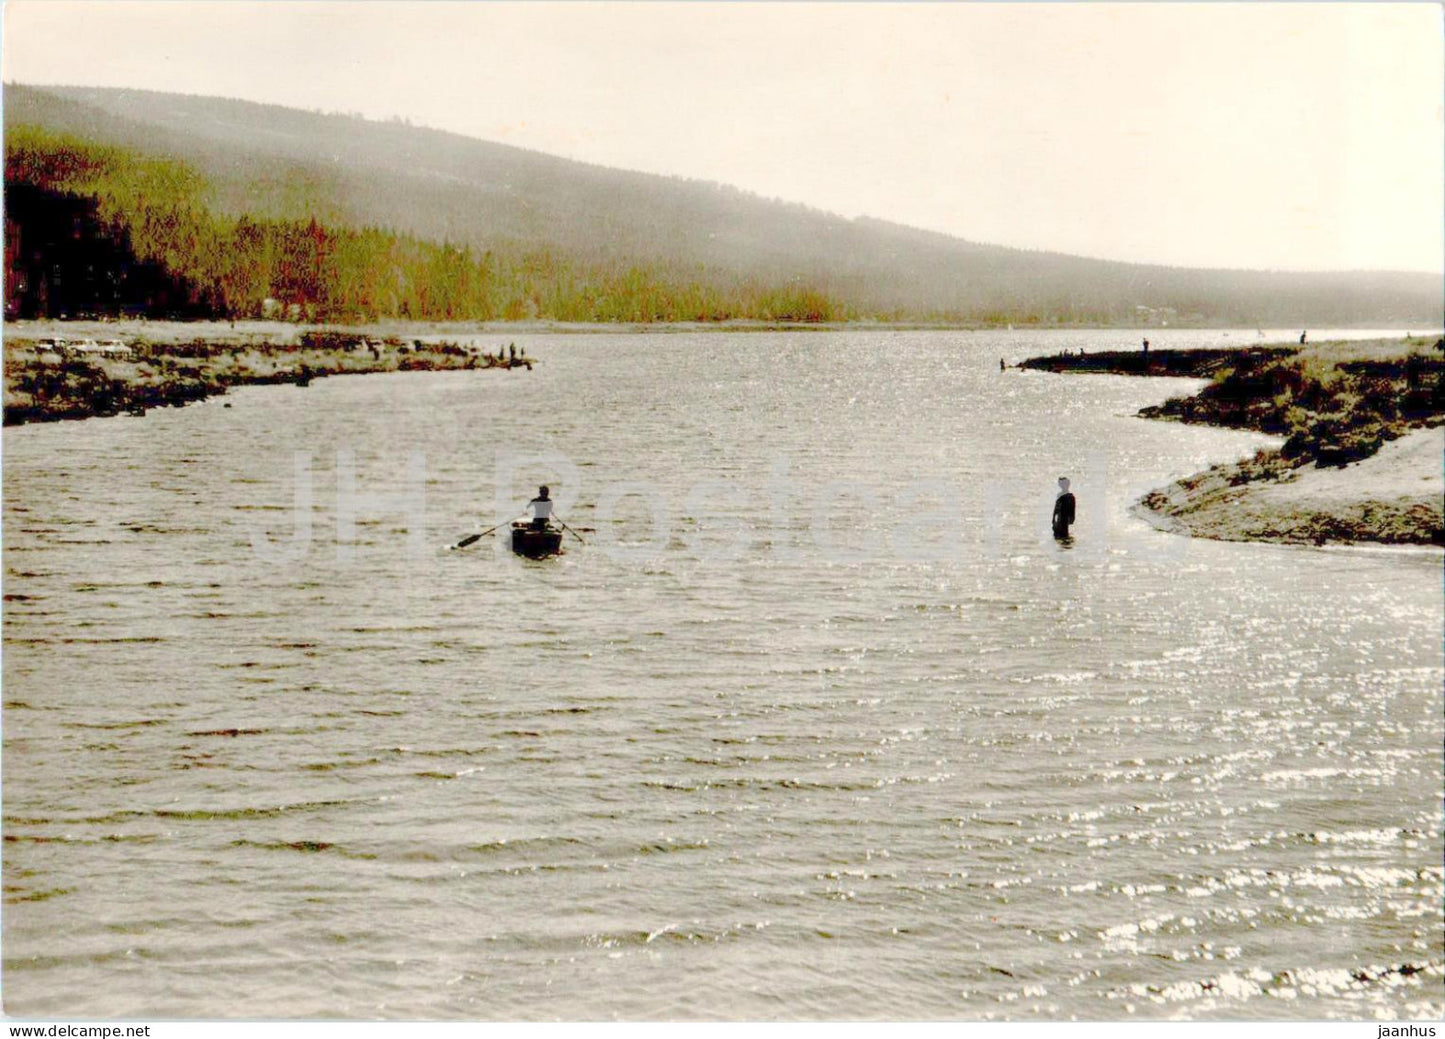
[3,329,1445,1020]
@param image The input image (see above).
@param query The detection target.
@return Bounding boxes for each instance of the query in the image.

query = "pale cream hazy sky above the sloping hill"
[3,0,1445,270]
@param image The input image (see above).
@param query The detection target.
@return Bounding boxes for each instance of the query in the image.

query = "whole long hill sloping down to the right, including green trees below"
[4,85,1442,328]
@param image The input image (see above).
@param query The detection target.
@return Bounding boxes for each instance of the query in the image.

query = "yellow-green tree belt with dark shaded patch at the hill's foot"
[4,126,863,322]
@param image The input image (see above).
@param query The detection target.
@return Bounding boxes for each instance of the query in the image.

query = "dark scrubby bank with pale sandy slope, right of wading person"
[1020,335,1445,545]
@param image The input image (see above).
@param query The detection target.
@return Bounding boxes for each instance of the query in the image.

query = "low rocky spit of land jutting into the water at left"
[4,331,533,426]
